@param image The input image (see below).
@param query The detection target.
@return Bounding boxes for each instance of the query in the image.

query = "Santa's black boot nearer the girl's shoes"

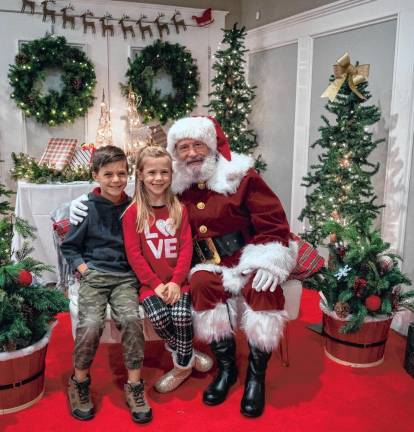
[203,337,237,405]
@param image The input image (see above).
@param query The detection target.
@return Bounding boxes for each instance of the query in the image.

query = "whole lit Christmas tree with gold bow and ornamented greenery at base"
[299,54,414,333]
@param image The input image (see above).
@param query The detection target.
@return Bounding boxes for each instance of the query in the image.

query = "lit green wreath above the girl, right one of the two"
[123,40,200,124]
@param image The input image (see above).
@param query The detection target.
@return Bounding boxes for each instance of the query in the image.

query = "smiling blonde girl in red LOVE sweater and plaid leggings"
[122,145,212,393]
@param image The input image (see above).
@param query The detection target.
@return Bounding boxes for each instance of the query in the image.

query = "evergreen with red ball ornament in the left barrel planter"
[0,184,68,352]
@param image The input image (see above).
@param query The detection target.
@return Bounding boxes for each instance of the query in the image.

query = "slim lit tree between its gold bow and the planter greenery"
[299,57,384,245]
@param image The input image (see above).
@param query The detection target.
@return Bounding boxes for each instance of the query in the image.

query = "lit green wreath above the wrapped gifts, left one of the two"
[8,35,96,126]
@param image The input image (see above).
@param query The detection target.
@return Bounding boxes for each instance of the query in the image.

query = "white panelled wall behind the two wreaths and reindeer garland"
[0,0,226,188]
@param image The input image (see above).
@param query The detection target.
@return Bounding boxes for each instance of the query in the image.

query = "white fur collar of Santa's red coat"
[171,152,254,195]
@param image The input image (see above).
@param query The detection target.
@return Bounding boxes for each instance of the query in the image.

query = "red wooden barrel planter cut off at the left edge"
[0,327,53,415]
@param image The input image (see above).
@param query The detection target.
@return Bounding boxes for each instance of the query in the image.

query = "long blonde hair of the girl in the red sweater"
[131,145,182,232]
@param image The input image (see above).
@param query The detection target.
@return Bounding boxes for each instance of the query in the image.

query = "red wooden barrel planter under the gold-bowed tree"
[323,313,392,368]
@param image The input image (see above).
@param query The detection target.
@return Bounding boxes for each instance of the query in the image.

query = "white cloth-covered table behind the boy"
[12,180,134,282]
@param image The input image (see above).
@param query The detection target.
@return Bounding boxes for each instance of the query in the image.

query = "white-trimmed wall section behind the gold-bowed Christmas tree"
[247,0,414,332]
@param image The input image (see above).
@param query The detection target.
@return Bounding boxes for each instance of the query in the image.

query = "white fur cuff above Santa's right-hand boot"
[240,302,288,352]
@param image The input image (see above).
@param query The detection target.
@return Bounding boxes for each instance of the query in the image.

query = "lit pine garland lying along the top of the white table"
[10,153,92,183]
